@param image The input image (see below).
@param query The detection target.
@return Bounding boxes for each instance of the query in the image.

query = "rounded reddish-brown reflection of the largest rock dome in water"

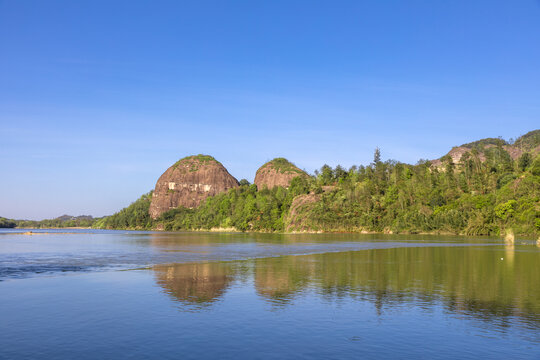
[154,263,231,304]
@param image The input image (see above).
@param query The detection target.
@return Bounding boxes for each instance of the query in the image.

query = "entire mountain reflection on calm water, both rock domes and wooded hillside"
[155,246,540,325]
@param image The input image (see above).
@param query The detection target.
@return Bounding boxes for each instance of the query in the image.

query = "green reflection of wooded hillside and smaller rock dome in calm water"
[254,247,540,316]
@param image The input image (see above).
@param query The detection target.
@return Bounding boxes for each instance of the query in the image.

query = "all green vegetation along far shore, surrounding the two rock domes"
[98,131,540,236]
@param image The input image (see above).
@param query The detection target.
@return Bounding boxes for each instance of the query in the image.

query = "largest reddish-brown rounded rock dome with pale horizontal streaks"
[149,155,239,219]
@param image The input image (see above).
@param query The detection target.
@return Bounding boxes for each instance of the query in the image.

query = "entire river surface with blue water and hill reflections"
[0,230,540,360]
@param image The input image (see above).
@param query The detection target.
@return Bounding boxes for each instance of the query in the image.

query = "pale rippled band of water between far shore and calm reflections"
[0,229,510,281]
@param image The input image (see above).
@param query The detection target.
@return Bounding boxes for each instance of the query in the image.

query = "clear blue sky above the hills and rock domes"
[0,0,540,219]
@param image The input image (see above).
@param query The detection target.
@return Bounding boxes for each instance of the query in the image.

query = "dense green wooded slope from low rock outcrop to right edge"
[292,148,540,235]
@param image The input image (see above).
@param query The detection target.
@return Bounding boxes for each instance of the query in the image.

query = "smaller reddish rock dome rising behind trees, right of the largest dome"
[254,158,307,190]
